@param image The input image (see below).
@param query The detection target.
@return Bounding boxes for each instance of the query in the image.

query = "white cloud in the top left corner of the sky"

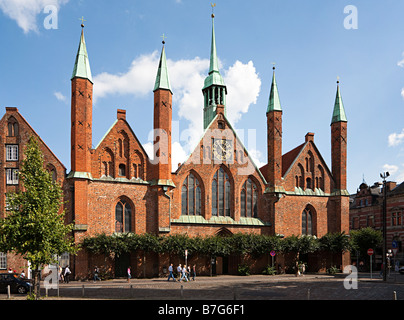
[0,0,69,33]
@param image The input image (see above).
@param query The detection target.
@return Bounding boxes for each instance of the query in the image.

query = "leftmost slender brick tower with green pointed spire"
[71,25,93,177]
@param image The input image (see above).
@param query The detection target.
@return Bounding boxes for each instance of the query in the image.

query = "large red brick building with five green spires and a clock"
[1,15,349,277]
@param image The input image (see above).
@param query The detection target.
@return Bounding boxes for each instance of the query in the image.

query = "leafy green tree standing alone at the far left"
[0,137,77,298]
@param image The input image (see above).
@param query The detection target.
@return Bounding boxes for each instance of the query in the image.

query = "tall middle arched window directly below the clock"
[212,168,231,217]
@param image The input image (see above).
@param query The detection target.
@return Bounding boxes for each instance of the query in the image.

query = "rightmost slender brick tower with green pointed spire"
[331,81,348,194]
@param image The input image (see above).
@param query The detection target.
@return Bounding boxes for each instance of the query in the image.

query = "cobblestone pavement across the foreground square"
[0,273,404,301]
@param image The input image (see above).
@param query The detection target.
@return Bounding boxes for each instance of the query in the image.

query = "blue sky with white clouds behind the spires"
[0,0,404,193]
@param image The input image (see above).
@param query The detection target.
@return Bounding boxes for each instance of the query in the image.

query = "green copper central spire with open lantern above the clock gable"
[202,14,227,129]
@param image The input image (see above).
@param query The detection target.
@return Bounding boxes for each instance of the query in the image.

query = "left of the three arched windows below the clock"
[181,173,201,216]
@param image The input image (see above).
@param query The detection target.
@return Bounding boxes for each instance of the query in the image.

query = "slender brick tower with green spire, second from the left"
[152,41,173,181]
